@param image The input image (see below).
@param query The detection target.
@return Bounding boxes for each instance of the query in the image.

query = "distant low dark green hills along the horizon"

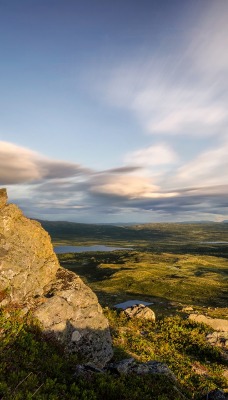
[36,220,228,251]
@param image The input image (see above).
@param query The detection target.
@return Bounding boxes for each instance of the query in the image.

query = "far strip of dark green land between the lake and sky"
[40,221,228,258]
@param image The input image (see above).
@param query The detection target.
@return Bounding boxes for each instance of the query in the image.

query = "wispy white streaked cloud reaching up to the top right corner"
[102,1,228,136]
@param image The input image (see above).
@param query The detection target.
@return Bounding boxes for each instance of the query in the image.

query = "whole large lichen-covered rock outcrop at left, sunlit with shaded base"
[0,189,112,367]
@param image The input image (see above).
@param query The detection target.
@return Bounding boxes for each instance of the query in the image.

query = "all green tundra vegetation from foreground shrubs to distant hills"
[0,221,228,400]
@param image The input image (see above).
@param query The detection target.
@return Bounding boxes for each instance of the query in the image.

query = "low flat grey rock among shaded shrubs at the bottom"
[107,358,176,380]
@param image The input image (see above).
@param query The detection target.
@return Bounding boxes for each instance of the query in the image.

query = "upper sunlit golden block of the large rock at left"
[0,190,59,303]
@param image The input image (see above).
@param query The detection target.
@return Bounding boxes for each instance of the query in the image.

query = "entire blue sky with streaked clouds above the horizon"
[0,0,228,223]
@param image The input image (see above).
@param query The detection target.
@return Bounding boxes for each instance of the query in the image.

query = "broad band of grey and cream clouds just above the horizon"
[0,141,228,222]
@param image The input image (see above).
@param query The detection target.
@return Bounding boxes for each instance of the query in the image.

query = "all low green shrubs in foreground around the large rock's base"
[0,309,224,400]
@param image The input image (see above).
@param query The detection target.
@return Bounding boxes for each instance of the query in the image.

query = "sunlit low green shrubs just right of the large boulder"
[106,310,226,398]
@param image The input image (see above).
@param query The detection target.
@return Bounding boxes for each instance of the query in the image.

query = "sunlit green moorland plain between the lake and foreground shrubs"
[58,251,228,317]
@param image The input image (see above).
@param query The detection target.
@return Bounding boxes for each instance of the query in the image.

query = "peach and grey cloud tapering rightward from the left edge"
[0,141,89,185]
